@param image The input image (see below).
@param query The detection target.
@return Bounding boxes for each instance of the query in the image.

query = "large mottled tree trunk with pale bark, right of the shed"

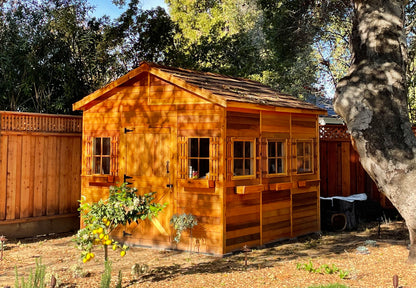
[334,0,416,263]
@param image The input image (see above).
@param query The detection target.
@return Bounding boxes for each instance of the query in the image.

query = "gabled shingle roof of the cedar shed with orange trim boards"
[73,62,326,114]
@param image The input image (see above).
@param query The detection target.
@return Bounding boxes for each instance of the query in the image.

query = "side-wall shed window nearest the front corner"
[232,140,255,176]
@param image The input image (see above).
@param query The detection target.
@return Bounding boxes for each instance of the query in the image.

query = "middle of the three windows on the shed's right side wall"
[267,140,286,175]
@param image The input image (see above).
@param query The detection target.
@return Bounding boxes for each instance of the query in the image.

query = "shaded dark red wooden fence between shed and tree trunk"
[319,125,393,208]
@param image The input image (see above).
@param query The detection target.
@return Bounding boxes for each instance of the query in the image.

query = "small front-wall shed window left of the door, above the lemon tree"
[92,137,111,175]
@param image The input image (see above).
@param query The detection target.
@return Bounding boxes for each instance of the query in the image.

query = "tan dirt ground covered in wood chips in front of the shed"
[0,222,416,288]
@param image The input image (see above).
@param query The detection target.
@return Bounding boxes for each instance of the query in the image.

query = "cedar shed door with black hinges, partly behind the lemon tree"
[123,127,172,236]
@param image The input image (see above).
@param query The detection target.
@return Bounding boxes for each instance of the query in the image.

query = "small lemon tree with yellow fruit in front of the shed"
[74,183,166,263]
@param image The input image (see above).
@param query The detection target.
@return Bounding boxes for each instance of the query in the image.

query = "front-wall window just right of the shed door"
[188,138,209,179]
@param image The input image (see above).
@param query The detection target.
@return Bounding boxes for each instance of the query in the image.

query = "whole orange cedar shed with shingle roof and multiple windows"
[73,62,326,254]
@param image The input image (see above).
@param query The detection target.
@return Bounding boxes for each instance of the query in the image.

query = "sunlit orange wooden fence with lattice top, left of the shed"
[0,112,82,238]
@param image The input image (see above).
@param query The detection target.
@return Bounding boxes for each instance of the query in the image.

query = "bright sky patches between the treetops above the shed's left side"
[88,0,167,18]
